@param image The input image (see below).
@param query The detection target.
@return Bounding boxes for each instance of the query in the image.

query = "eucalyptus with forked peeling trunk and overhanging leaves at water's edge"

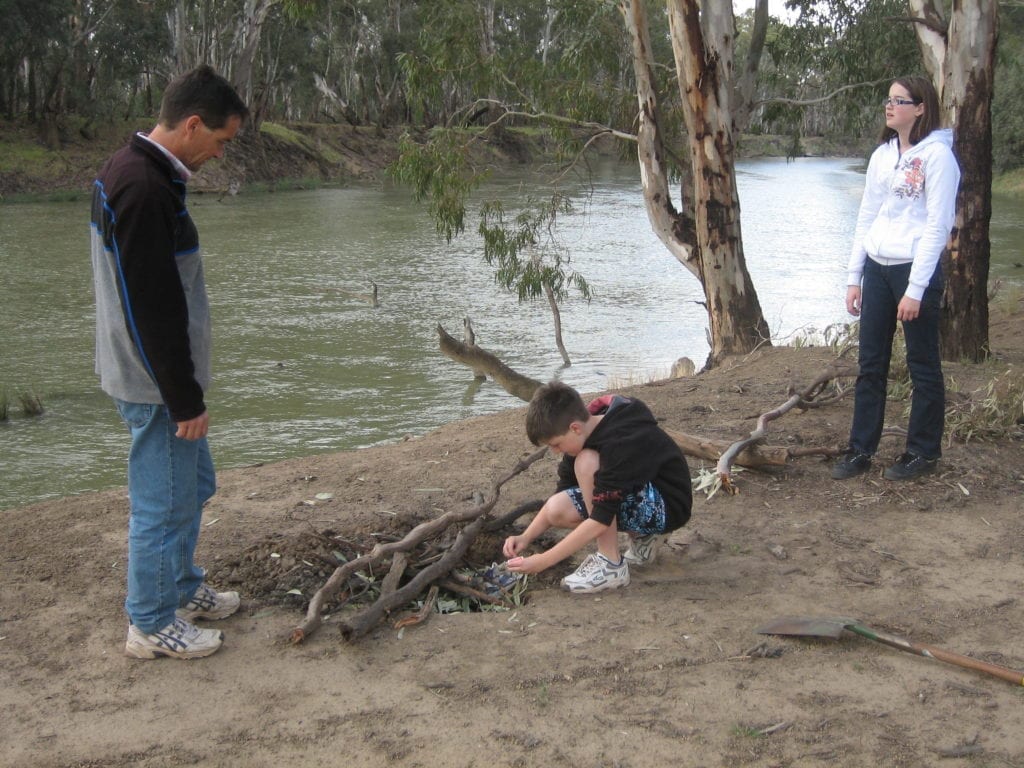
[395,0,770,372]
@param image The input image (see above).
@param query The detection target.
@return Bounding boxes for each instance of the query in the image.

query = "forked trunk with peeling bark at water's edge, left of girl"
[620,0,770,366]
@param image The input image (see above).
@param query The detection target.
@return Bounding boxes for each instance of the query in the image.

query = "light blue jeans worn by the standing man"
[114,398,216,633]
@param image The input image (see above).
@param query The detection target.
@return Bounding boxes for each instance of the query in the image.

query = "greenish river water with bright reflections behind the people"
[0,159,1024,509]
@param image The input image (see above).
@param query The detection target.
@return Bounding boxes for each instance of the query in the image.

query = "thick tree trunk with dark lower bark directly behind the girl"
[908,0,998,361]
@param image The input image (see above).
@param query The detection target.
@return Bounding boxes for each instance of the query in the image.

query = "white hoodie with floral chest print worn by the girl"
[847,128,959,301]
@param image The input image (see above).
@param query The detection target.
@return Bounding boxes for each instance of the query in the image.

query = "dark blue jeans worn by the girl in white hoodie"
[850,258,945,459]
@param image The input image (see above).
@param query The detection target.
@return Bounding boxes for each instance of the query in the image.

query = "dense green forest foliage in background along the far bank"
[0,0,1024,172]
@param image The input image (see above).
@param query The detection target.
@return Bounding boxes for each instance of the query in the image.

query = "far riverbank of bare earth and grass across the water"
[0,115,867,202]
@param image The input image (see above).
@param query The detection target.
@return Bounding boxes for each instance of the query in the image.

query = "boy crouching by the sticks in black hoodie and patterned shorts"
[503,381,693,593]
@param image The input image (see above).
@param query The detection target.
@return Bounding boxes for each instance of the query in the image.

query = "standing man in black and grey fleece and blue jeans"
[92,67,249,658]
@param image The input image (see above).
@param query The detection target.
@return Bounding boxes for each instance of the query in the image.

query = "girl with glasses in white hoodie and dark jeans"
[833,77,959,480]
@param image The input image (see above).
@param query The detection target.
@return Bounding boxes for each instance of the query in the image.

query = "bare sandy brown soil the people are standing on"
[0,313,1024,768]
